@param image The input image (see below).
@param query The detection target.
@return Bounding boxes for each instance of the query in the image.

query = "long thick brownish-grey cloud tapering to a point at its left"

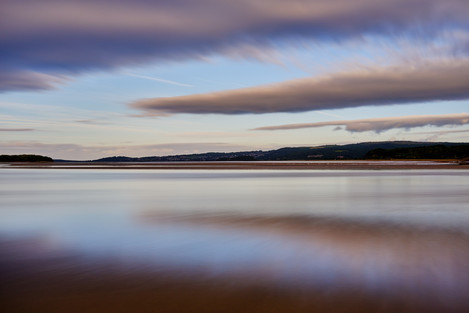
[131,59,469,114]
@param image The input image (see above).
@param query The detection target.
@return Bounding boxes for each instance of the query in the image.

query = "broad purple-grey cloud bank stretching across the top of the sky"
[0,0,469,90]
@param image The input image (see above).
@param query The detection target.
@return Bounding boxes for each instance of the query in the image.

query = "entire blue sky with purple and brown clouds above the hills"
[0,0,469,160]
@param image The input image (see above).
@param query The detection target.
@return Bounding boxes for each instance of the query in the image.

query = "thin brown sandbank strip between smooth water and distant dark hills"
[4,160,469,170]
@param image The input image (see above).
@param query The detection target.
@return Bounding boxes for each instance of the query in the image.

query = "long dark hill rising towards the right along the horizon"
[82,141,469,162]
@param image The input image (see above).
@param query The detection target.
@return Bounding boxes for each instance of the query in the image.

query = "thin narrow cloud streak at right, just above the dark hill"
[253,113,469,133]
